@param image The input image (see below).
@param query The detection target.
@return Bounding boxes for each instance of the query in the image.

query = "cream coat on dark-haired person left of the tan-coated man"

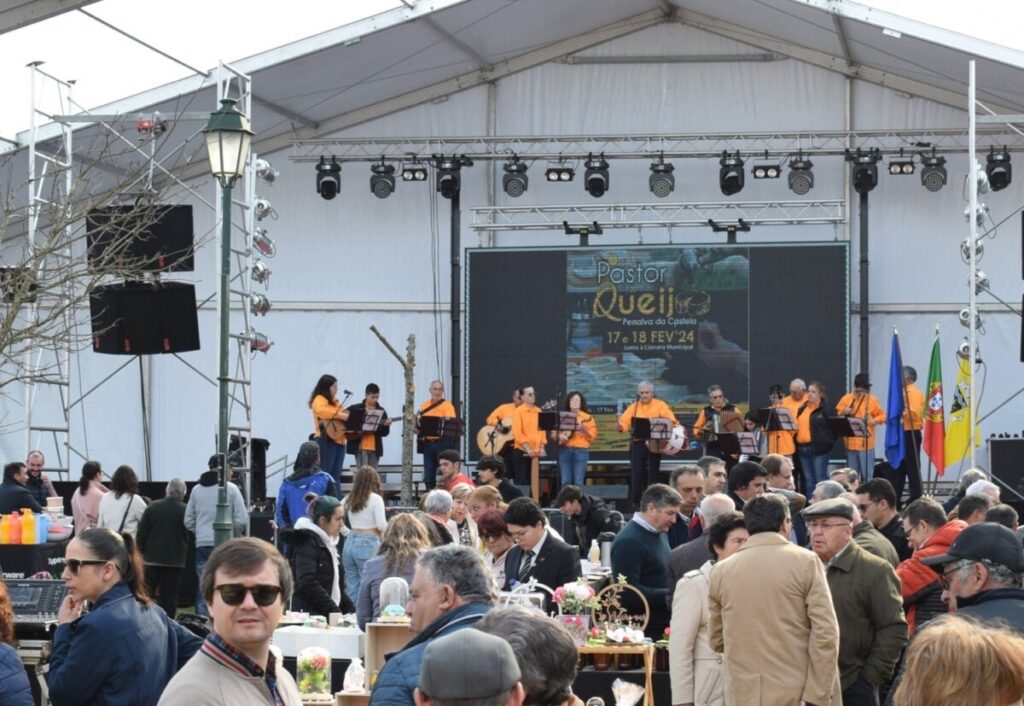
[669,562,725,706]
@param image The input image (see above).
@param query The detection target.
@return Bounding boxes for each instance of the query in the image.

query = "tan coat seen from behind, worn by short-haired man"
[708,532,842,706]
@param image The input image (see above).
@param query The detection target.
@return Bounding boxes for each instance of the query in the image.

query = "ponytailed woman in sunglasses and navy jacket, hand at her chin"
[47,529,202,706]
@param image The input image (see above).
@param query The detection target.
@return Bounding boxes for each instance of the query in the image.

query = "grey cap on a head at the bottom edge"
[419,628,519,701]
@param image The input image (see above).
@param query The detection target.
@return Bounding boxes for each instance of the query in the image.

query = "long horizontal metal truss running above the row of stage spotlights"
[290,125,1024,162]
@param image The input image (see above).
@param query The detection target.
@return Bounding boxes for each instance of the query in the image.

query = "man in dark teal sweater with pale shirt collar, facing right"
[611,483,683,639]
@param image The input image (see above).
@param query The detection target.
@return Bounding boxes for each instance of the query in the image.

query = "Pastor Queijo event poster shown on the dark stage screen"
[565,247,750,451]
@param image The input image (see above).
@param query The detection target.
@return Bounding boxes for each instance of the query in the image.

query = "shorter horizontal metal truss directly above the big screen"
[470,200,846,233]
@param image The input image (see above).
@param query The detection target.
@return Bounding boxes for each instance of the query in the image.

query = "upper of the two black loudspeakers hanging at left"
[85,205,196,273]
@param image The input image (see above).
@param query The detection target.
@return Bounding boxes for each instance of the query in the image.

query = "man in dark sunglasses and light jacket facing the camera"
[160,537,302,706]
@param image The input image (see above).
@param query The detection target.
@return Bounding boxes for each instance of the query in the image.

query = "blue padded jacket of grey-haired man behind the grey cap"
[368,604,490,706]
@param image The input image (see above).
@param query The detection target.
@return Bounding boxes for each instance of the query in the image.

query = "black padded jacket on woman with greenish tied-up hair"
[281,520,355,617]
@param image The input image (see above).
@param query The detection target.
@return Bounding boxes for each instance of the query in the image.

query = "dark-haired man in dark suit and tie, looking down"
[504,498,583,610]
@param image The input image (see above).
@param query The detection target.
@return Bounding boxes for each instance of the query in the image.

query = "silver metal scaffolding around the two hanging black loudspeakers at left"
[25,64,266,494]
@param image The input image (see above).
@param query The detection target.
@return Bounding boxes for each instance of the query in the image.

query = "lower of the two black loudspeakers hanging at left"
[89,282,200,356]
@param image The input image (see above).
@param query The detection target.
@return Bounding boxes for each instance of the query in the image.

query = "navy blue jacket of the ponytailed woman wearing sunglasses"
[47,583,203,706]
